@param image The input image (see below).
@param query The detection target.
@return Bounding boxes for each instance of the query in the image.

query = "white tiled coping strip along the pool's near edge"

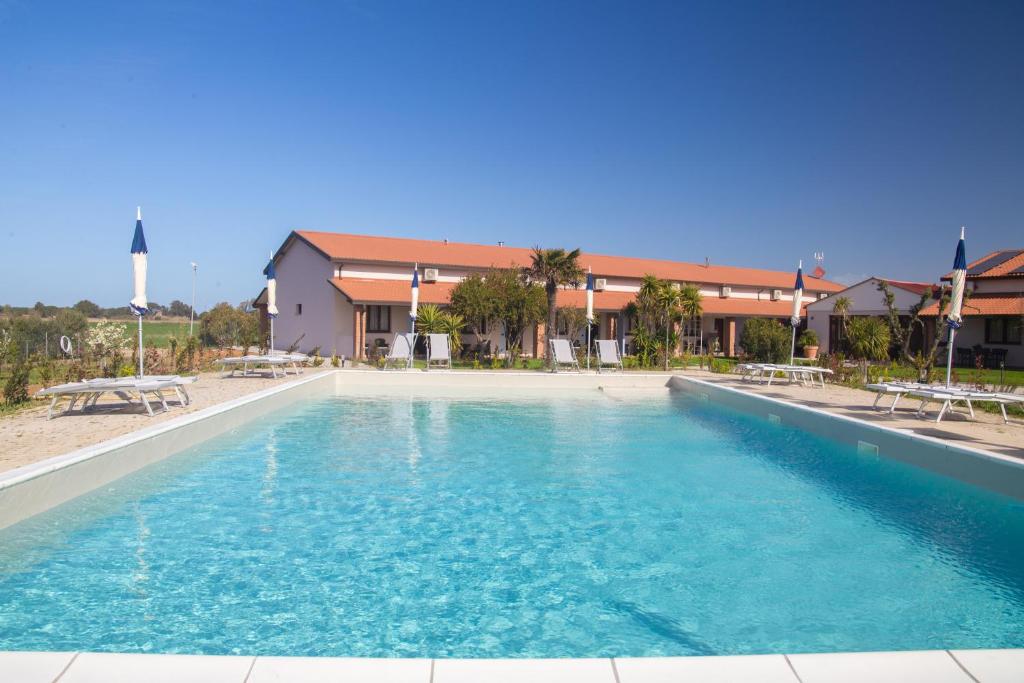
[0,649,1024,683]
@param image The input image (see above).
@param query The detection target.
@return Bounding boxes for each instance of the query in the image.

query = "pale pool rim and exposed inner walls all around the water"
[0,370,1024,683]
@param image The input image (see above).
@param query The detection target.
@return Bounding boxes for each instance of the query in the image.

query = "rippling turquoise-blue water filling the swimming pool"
[0,396,1024,657]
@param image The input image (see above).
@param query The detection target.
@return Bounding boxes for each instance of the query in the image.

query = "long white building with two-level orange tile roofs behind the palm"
[257,230,843,358]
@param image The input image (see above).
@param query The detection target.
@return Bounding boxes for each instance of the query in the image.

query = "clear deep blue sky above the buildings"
[0,0,1024,307]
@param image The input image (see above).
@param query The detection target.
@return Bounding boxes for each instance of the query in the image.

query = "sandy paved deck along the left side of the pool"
[0,368,333,472]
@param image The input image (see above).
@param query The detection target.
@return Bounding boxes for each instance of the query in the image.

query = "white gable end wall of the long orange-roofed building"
[273,240,339,354]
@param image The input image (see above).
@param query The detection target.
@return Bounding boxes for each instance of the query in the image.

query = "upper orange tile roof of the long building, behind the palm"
[285,230,844,292]
